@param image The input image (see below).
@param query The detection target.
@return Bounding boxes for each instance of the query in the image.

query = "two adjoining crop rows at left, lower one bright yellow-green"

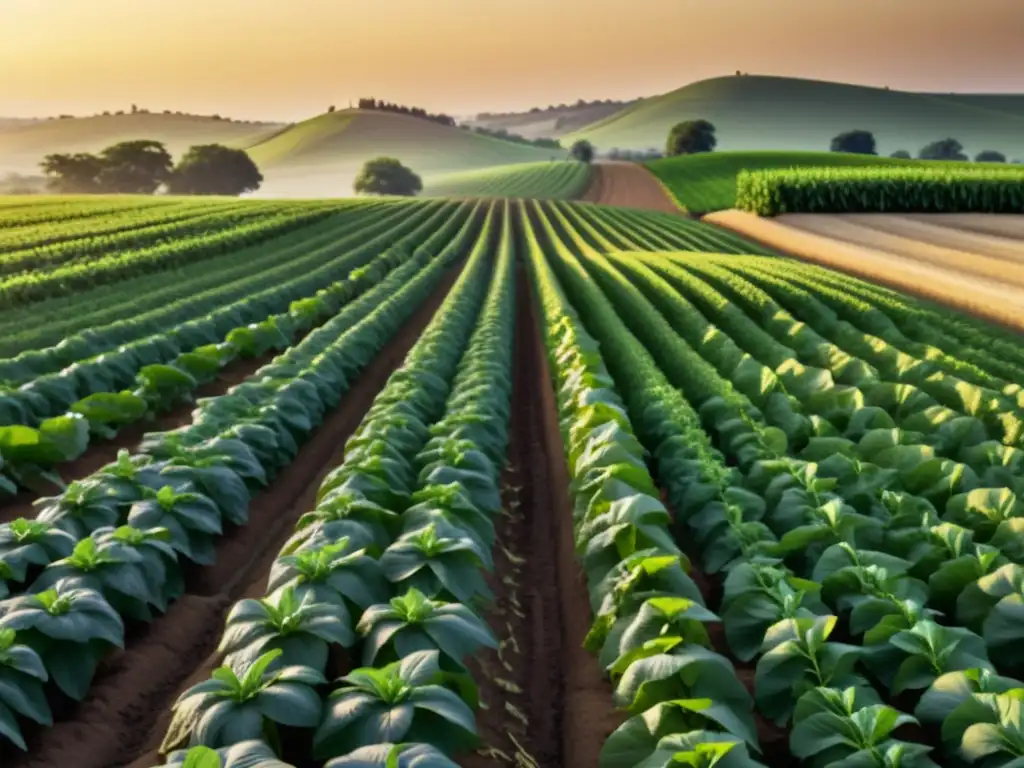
[0,205,468,492]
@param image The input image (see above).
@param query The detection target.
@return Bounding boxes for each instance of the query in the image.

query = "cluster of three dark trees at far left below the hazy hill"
[39,139,263,196]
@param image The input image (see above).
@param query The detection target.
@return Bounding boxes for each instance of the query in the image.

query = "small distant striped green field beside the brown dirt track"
[424,160,593,200]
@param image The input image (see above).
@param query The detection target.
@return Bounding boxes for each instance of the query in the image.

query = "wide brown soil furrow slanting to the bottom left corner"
[0,268,459,768]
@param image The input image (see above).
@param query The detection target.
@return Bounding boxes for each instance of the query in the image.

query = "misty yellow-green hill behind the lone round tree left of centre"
[249,110,573,198]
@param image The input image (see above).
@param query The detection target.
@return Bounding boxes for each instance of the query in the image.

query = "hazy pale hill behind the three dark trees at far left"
[0,113,282,174]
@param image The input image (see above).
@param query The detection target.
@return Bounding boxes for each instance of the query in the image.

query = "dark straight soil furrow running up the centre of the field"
[460,267,569,768]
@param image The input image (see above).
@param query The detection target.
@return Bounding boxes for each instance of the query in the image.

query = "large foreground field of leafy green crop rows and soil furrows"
[0,193,1024,768]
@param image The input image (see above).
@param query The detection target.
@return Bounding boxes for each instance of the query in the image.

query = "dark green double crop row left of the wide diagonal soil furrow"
[0,201,479,743]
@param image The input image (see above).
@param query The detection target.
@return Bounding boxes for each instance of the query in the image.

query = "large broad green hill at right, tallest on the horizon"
[562,75,1024,158]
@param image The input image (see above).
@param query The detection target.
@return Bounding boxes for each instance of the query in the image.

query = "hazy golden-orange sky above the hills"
[0,0,1024,120]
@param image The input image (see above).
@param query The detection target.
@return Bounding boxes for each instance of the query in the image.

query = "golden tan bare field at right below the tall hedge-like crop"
[703,210,1024,331]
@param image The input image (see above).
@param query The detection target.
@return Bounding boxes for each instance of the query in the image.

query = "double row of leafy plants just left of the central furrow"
[149,201,514,768]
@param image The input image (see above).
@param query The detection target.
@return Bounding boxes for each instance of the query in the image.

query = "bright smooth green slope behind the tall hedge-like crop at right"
[646,152,1001,213]
